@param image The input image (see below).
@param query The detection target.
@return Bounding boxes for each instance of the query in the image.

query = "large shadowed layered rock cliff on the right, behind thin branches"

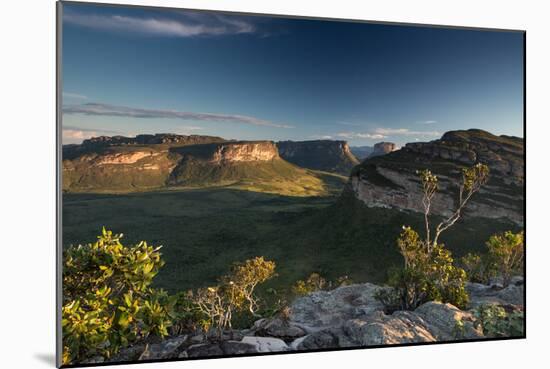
[346,130,524,225]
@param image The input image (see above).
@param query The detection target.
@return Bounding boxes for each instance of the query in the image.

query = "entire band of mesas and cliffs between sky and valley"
[63,129,525,224]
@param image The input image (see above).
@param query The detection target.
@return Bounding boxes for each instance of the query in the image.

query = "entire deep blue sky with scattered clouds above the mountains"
[62,3,523,146]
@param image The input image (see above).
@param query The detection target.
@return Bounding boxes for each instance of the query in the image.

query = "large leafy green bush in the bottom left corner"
[62,228,174,364]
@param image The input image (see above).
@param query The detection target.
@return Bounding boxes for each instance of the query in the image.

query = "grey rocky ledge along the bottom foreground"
[109,277,524,363]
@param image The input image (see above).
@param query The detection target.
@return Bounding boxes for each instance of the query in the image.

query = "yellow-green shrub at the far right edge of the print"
[487,231,524,287]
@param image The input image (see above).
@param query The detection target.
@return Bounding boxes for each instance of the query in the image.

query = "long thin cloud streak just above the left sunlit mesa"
[63,103,293,128]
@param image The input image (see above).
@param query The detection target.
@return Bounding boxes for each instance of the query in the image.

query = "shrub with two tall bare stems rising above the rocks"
[378,164,489,310]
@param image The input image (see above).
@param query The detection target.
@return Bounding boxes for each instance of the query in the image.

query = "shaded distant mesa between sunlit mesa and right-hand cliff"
[277,140,359,175]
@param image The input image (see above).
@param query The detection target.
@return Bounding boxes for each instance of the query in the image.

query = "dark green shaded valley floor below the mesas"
[63,189,519,294]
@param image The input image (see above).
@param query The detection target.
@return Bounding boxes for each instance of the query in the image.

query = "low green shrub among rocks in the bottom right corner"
[474,304,525,337]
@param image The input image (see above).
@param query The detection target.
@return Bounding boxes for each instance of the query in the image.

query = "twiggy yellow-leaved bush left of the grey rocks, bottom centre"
[194,257,275,337]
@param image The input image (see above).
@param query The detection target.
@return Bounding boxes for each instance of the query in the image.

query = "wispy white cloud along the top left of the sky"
[63,12,255,37]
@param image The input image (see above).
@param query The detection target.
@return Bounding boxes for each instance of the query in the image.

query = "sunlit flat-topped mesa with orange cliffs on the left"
[63,134,340,196]
